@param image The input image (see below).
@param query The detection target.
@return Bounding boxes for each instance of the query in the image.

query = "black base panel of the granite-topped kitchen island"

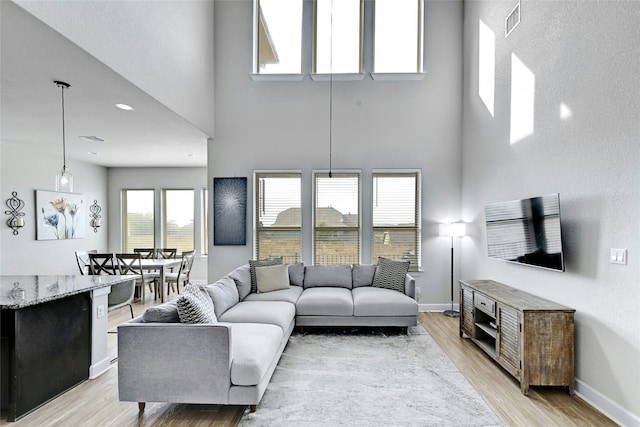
[0,292,91,421]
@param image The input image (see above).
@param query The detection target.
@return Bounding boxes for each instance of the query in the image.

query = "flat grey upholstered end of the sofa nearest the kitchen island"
[118,318,233,404]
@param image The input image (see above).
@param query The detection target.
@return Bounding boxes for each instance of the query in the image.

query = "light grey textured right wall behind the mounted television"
[462,1,640,425]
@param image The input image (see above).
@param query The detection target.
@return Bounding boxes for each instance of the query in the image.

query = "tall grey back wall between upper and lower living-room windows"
[208,0,462,303]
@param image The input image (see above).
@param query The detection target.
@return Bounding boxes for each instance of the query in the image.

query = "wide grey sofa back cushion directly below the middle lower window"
[296,288,353,316]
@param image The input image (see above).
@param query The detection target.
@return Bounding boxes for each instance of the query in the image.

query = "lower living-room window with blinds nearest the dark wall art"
[254,172,302,264]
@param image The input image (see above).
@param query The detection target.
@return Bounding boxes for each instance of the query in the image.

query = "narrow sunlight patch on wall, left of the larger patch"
[478,19,496,117]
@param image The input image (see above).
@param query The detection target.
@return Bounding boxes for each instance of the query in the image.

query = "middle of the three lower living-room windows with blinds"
[313,172,360,265]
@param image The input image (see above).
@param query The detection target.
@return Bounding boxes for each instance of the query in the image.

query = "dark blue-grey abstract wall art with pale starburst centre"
[213,178,247,246]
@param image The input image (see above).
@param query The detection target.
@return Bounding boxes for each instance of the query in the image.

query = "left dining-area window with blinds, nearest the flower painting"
[122,190,155,252]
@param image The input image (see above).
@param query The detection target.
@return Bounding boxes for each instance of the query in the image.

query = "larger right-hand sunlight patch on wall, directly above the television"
[510,53,536,144]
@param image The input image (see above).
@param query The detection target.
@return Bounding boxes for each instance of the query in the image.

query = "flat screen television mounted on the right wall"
[485,193,564,271]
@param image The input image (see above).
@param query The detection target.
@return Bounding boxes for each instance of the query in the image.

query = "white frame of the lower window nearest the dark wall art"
[253,170,304,264]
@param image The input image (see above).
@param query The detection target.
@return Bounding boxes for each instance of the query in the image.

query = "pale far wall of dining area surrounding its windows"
[107,168,207,283]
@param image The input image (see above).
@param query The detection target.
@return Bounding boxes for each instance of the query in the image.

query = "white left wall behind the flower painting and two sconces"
[0,141,108,275]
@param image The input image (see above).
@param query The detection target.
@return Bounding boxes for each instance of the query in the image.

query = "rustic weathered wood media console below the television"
[460,280,575,395]
